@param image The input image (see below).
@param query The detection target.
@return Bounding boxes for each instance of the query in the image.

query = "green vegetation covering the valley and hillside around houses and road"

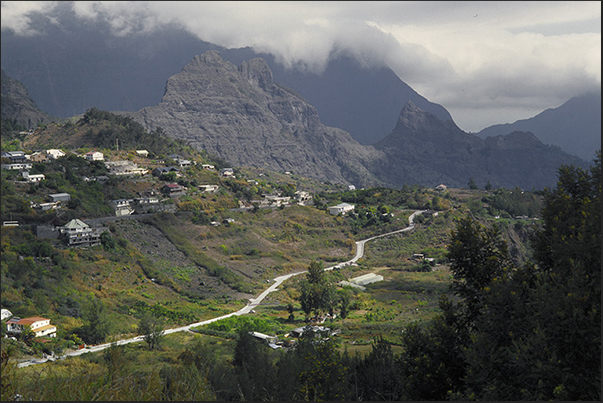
[0,111,601,400]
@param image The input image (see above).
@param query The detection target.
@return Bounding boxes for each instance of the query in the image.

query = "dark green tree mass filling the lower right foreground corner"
[464,151,601,401]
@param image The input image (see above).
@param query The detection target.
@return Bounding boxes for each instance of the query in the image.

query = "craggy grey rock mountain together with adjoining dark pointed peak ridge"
[123,51,585,188]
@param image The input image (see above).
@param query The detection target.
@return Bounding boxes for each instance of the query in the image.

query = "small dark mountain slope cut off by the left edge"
[2,70,56,129]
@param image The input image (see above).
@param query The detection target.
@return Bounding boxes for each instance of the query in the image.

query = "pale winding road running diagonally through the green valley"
[17,210,424,368]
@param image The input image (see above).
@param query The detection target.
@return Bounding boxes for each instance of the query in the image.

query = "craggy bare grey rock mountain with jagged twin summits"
[128,51,381,186]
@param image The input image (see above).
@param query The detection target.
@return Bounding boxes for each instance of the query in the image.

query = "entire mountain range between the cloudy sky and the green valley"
[1,9,601,192]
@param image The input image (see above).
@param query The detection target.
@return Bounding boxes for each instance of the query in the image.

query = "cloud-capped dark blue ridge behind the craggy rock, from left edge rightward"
[0,6,450,144]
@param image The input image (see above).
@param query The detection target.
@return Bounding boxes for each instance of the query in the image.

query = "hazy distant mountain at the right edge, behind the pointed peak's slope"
[477,89,601,161]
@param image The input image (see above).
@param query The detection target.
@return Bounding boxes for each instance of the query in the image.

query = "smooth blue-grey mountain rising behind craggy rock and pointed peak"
[220,48,452,144]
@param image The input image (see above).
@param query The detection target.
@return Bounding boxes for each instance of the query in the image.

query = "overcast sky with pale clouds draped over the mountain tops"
[1,1,601,132]
